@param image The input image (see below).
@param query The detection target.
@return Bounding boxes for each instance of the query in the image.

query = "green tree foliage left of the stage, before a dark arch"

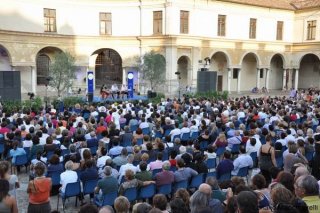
[49,52,76,96]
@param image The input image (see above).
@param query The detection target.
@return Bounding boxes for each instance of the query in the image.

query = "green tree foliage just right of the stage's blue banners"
[140,51,166,90]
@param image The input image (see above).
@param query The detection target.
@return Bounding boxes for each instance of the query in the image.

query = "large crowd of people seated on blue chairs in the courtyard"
[0,90,320,213]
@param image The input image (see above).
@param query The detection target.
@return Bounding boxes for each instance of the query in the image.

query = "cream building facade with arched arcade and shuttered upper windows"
[0,0,320,94]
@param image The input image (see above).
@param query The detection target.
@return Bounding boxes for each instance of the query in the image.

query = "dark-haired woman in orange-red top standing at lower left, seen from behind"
[27,162,51,213]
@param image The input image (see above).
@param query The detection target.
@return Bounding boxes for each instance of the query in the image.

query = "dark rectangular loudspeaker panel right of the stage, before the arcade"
[197,71,217,92]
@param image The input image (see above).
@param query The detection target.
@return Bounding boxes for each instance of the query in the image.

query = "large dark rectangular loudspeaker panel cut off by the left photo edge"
[0,71,21,101]
